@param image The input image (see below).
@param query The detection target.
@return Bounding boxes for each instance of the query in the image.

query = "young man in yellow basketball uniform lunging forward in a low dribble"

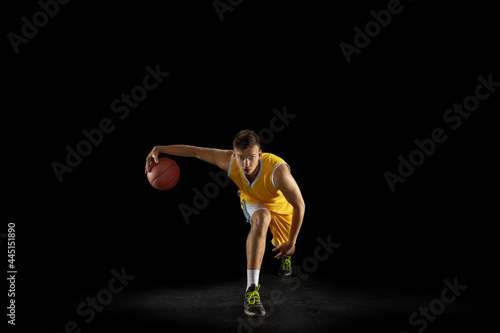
[145,130,305,316]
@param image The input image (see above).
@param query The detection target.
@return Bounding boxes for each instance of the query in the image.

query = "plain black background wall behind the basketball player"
[2,1,500,330]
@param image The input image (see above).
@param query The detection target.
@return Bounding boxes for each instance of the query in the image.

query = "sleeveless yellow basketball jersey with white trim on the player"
[228,153,293,214]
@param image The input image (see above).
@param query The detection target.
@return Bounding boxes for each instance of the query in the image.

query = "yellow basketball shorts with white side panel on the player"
[238,191,293,246]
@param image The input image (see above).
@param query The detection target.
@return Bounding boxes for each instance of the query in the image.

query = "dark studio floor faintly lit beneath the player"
[32,273,498,333]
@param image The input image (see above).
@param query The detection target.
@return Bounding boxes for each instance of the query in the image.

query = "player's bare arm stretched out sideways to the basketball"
[145,145,232,173]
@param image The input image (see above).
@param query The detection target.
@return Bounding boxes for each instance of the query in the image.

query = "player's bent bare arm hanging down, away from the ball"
[273,164,306,259]
